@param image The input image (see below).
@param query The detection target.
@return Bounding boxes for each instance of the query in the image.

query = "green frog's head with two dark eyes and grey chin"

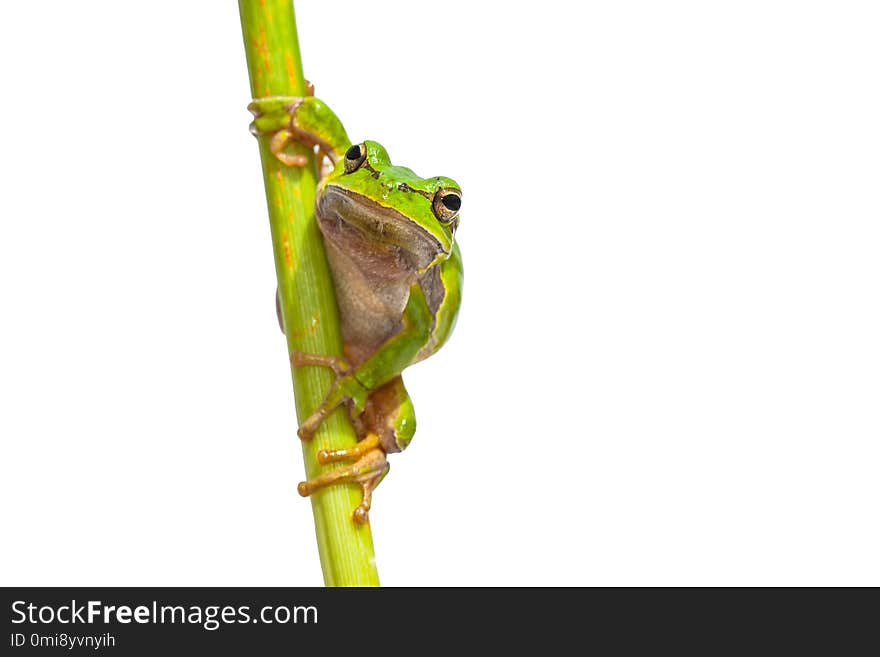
[318,141,461,272]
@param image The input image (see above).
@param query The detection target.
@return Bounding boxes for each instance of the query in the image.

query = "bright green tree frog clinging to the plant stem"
[248,91,464,524]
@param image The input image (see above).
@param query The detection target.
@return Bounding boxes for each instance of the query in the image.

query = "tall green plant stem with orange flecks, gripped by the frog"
[238,0,379,586]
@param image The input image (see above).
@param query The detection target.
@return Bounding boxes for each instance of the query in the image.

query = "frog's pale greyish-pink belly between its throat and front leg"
[324,239,415,366]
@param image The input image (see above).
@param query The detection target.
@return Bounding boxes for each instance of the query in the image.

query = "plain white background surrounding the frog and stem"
[0,0,880,586]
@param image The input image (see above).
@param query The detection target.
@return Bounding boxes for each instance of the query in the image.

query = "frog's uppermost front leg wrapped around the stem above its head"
[248,96,351,172]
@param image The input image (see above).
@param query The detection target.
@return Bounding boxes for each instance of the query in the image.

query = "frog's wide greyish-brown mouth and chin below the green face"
[317,185,449,272]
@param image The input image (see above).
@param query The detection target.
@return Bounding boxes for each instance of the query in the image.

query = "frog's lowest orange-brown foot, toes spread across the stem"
[297,435,390,524]
